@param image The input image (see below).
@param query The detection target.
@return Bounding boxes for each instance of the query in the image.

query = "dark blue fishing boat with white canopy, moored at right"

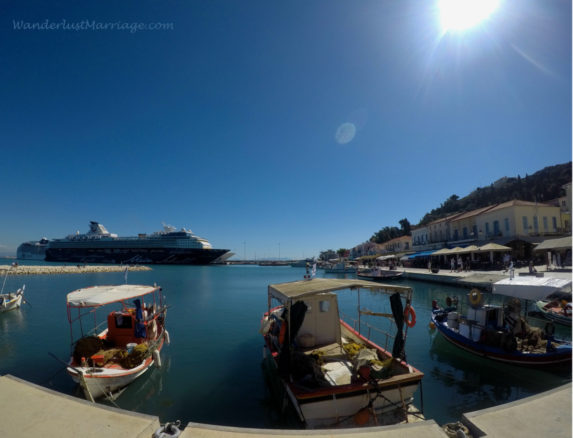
[430,277,572,367]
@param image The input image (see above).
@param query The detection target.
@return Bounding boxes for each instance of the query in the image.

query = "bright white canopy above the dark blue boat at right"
[492,276,571,300]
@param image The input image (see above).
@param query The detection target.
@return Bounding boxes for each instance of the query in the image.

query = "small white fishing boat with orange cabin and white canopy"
[66,284,169,401]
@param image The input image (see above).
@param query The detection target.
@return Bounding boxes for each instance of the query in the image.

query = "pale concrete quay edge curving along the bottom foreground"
[0,375,571,438]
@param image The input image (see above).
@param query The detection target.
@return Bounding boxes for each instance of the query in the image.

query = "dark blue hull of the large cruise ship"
[46,247,228,265]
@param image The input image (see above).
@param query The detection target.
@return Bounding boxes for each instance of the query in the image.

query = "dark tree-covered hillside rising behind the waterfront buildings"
[418,162,571,226]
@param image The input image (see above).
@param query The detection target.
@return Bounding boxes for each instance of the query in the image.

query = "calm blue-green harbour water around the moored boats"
[0,266,571,428]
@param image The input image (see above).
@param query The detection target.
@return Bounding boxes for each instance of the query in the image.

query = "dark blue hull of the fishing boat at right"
[432,315,571,367]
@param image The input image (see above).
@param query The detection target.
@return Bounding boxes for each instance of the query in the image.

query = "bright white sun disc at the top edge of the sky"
[439,0,499,32]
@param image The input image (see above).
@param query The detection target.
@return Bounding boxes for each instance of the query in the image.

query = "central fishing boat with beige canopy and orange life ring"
[261,278,424,428]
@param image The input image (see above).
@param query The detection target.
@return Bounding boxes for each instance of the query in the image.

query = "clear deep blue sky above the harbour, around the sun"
[0,0,571,258]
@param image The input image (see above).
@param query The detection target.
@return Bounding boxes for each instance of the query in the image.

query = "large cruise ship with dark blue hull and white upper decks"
[46,221,233,265]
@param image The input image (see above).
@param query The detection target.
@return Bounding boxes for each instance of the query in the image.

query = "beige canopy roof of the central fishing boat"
[269,278,412,302]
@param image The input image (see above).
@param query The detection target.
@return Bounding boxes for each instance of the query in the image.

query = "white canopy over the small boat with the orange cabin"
[67,284,159,307]
